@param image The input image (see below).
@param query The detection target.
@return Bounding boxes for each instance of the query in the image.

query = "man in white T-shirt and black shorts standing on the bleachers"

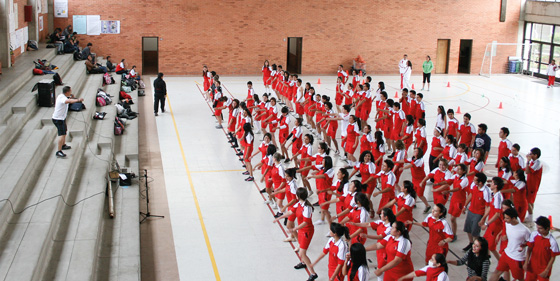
[52,86,84,157]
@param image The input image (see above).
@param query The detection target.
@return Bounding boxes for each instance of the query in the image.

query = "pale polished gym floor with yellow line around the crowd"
[140,75,560,280]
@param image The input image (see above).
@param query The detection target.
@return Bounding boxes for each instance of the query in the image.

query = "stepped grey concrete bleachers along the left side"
[0,49,140,280]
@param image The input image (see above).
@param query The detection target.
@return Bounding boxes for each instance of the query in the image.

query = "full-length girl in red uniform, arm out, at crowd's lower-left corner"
[274,187,318,281]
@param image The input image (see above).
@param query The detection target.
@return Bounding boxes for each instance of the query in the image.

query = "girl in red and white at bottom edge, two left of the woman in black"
[366,221,414,281]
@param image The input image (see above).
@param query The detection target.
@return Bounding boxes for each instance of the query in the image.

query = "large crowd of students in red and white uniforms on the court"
[202,61,560,281]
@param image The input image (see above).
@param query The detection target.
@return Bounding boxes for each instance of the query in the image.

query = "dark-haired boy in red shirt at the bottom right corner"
[523,216,560,281]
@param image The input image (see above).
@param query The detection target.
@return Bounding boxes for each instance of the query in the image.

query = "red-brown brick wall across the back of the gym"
[54,0,521,75]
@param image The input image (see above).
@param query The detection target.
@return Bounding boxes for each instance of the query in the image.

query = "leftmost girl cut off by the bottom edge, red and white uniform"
[313,222,350,281]
